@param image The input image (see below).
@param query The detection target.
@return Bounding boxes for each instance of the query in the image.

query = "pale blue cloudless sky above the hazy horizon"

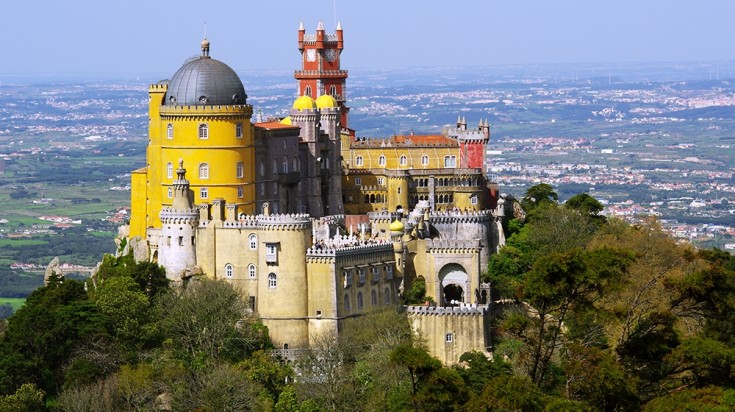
[0,0,735,80]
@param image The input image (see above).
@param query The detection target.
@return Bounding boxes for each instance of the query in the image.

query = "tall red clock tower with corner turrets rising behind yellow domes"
[294,22,350,128]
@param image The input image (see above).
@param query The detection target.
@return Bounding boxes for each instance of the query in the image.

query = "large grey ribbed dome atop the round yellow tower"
[164,53,247,106]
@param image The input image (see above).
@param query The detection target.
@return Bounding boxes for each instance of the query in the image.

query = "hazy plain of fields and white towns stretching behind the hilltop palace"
[0,64,735,280]
